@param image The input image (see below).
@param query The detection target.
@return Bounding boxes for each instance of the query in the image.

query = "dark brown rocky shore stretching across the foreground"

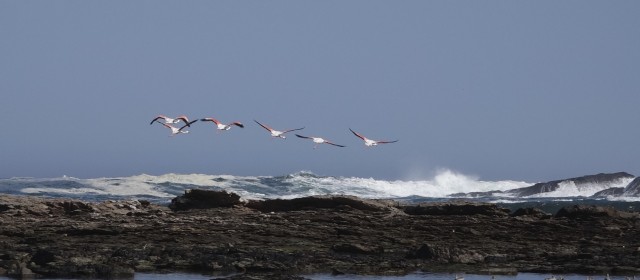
[0,190,640,279]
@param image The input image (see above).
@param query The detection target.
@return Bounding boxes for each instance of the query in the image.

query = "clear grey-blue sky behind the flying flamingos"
[0,0,640,182]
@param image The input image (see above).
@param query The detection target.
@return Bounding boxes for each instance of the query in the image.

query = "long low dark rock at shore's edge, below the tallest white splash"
[403,203,510,216]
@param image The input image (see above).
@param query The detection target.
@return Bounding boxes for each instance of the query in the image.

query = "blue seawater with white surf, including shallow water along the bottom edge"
[0,171,640,280]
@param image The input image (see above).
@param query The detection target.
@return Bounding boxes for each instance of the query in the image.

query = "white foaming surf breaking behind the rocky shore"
[0,170,628,203]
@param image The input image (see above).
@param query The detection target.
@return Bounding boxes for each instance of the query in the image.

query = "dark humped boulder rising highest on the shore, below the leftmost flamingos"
[169,189,241,211]
